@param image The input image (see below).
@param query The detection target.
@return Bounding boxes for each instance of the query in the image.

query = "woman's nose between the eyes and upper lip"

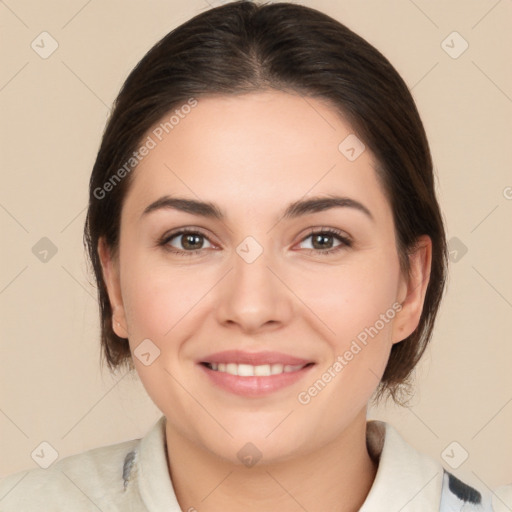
[216,242,293,333]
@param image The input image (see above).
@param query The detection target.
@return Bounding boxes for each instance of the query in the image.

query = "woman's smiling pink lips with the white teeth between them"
[199,350,314,396]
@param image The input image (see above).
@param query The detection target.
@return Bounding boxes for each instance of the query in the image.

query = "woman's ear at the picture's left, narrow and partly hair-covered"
[98,237,128,338]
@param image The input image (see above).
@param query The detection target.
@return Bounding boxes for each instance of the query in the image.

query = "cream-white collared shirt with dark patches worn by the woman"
[0,416,512,512]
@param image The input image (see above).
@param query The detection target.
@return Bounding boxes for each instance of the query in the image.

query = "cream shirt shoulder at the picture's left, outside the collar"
[0,439,140,512]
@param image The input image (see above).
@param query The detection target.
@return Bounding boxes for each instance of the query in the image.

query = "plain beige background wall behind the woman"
[0,0,512,487]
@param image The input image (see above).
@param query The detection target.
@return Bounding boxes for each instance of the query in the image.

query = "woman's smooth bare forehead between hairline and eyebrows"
[124,91,387,222]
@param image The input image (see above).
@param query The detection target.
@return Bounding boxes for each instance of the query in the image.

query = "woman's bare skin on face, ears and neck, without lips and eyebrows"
[98,91,431,512]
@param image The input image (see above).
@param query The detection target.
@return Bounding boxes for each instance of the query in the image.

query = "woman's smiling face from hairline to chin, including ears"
[100,92,429,462]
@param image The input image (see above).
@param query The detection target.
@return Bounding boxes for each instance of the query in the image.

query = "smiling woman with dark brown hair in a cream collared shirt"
[0,2,508,512]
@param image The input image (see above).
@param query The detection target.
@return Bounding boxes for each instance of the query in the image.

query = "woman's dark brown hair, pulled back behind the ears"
[84,1,447,400]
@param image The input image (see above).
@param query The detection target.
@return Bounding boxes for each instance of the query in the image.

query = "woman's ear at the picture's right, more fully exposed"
[392,235,432,343]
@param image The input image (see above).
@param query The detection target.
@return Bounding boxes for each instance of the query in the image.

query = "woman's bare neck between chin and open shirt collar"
[166,410,377,512]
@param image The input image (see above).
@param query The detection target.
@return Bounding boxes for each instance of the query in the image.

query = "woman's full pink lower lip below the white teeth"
[199,364,314,397]
